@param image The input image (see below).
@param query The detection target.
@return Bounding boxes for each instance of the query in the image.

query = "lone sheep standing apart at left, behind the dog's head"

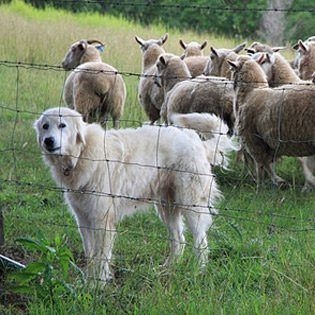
[62,39,127,128]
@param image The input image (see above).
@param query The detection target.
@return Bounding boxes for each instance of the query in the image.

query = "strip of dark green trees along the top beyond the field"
[18,0,315,45]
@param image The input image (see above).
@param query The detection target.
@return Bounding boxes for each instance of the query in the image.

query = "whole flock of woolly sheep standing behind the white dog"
[62,34,315,189]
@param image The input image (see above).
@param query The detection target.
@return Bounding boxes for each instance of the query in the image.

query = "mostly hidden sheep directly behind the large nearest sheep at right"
[252,53,315,191]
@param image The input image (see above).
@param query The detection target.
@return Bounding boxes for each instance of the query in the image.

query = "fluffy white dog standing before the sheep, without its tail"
[34,108,232,281]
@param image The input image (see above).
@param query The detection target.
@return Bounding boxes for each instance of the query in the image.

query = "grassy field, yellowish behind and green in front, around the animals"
[0,1,315,315]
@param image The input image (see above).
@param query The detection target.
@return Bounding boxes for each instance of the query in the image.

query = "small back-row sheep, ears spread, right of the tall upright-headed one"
[179,39,209,77]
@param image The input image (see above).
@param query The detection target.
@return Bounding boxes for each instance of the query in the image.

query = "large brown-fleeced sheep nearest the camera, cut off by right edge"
[228,56,315,187]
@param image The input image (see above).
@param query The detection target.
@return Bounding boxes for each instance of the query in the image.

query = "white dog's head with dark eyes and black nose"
[34,107,86,175]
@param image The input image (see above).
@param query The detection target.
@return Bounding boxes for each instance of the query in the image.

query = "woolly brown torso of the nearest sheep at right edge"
[239,87,315,156]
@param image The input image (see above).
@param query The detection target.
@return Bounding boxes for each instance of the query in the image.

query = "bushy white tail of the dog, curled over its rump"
[170,113,238,168]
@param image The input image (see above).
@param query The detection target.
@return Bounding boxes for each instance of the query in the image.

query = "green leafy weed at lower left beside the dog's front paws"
[9,235,83,300]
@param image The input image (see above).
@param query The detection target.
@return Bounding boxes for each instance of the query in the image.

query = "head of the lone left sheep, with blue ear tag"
[62,39,104,70]
